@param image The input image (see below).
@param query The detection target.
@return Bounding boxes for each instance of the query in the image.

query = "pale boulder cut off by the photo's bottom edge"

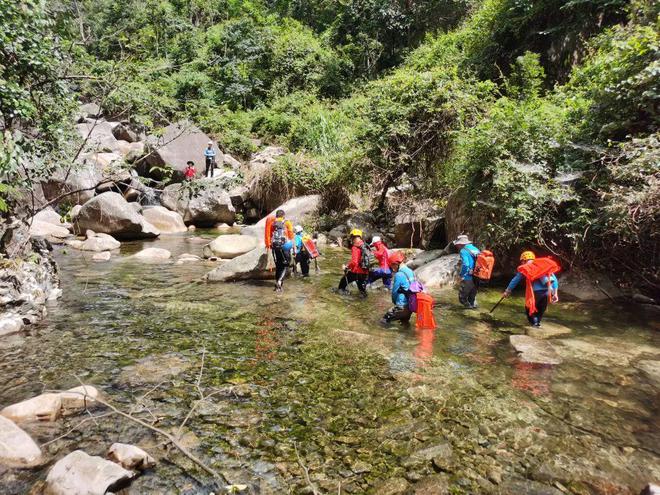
[44,450,133,495]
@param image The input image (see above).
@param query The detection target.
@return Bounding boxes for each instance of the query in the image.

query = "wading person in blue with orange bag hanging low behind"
[381,251,435,329]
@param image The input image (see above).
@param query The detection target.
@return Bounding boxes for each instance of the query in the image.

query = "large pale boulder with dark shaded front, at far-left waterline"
[74,192,160,239]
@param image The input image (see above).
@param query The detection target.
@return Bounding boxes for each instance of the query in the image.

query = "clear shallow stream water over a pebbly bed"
[0,234,660,494]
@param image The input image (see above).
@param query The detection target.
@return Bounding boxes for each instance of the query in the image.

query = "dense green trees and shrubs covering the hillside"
[0,0,660,292]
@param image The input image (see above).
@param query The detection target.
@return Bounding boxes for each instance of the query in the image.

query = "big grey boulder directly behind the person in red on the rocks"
[143,121,211,178]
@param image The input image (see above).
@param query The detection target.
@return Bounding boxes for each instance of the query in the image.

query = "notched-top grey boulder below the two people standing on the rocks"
[160,181,236,227]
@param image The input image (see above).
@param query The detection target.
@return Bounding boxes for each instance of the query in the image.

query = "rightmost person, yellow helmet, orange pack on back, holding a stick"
[502,251,561,327]
